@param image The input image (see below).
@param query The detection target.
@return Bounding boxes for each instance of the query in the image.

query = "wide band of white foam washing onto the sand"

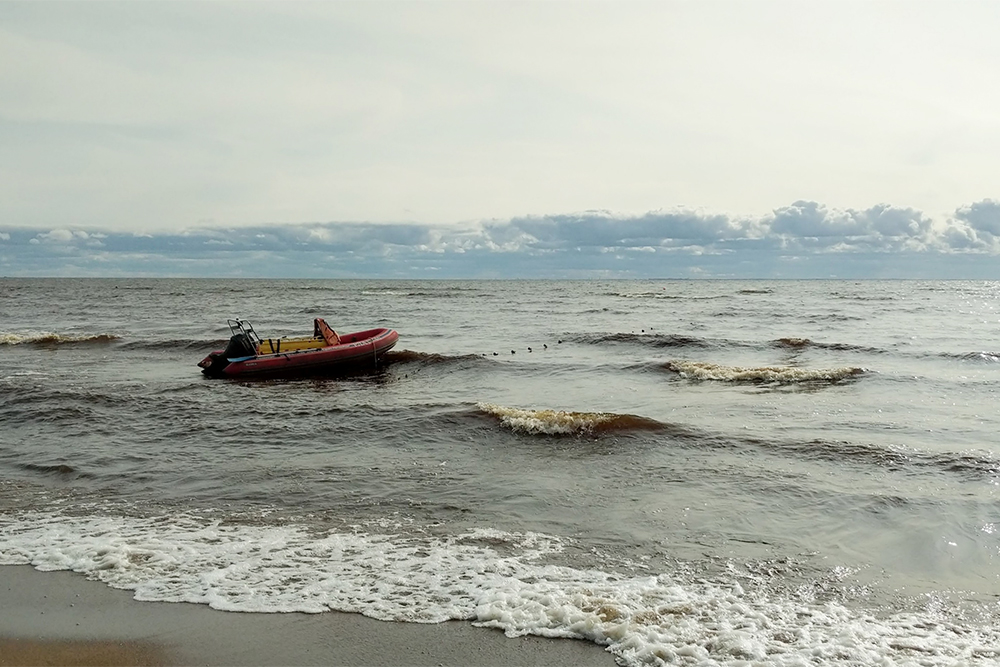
[0,513,1000,667]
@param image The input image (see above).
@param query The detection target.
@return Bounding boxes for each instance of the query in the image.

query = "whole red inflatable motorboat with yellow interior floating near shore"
[198,318,399,378]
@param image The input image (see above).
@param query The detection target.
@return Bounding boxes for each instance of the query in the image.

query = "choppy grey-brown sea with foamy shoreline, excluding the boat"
[0,278,1000,667]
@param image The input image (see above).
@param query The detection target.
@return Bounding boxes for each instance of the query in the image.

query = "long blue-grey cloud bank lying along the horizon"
[0,199,1000,278]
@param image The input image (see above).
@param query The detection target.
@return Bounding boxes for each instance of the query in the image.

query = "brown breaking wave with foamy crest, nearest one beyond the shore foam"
[476,403,666,435]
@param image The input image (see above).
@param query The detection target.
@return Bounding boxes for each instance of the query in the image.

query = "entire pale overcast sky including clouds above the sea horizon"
[0,0,1000,279]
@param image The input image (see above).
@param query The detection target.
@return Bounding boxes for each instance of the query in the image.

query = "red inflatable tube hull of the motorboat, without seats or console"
[198,328,399,378]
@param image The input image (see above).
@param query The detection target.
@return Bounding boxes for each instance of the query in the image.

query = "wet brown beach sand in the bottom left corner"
[0,565,615,667]
